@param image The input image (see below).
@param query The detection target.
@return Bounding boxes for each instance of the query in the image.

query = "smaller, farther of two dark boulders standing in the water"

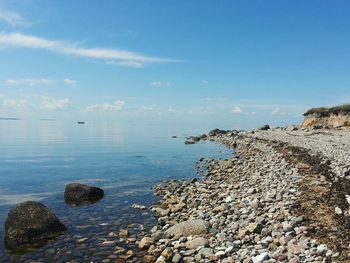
[64,183,104,205]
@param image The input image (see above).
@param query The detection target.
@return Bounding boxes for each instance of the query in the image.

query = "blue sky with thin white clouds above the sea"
[0,0,350,129]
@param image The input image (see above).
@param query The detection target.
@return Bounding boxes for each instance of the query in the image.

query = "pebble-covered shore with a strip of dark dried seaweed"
[138,127,350,263]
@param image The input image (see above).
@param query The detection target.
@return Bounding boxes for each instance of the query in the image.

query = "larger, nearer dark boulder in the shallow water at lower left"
[5,201,66,250]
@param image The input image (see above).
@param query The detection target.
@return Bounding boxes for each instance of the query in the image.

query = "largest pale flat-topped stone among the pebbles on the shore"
[165,219,210,237]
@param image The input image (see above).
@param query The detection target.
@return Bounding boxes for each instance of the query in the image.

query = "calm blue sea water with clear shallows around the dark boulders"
[0,121,231,262]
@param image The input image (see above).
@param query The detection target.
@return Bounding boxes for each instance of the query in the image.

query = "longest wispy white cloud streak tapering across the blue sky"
[0,32,180,67]
